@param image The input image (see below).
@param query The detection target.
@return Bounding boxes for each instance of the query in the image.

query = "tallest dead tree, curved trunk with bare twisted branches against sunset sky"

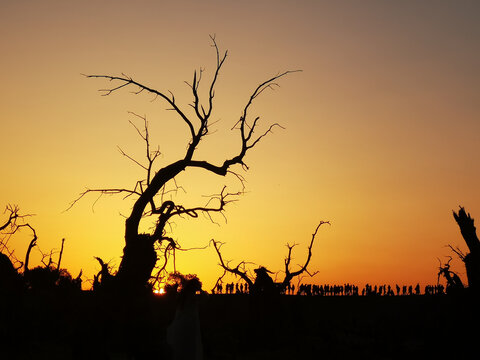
[72,37,297,291]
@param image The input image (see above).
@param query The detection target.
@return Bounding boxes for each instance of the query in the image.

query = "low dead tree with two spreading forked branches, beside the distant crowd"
[211,221,330,291]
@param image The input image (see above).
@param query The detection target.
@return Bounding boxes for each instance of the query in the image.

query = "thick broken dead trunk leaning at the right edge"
[453,206,480,292]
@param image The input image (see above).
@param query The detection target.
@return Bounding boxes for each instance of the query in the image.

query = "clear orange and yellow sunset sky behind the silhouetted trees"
[0,0,480,289]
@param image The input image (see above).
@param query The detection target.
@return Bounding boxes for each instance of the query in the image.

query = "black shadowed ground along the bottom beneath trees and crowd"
[0,292,480,359]
